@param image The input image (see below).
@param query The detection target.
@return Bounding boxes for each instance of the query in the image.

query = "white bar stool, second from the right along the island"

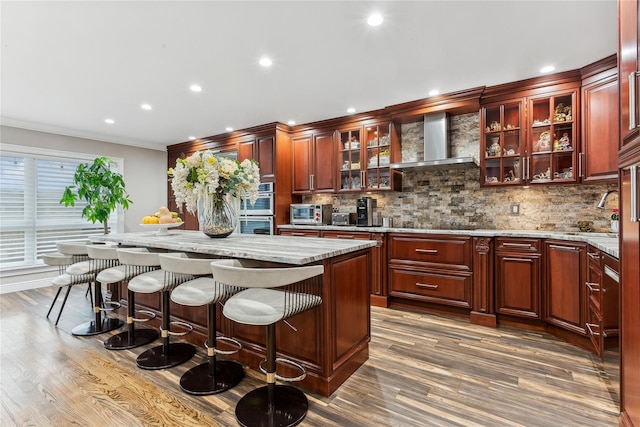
[171,266,244,395]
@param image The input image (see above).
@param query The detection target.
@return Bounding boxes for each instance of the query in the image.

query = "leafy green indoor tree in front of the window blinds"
[60,157,133,234]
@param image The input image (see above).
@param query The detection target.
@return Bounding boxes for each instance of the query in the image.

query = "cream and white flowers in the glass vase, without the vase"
[167,150,260,214]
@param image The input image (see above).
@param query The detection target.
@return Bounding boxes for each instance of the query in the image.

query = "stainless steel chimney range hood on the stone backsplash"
[389,113,479,172]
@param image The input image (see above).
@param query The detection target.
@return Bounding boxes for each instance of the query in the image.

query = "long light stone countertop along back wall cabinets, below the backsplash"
[278,225,620,258]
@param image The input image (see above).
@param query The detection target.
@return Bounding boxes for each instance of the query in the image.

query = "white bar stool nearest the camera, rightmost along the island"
[211,259,324,427]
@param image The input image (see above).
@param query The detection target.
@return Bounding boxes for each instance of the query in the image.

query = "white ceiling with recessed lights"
[0,0,617,149]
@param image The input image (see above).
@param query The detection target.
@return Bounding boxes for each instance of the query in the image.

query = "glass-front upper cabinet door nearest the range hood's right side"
[480,100,525,185]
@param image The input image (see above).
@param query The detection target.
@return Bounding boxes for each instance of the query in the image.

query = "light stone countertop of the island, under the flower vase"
[92,230,376,265]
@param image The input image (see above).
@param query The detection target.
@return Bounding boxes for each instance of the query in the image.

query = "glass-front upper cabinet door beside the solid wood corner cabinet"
[525,90,579,184]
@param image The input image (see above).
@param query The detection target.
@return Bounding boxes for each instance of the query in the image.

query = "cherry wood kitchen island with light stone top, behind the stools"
[94,230,376,396]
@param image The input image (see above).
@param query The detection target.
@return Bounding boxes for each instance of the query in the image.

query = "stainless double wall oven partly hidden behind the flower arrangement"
[238,182,274,234]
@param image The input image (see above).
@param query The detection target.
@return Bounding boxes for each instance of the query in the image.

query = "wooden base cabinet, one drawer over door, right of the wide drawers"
[495,237,542,319]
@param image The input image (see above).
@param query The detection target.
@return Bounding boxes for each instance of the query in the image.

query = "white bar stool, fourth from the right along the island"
[102,248,160,350]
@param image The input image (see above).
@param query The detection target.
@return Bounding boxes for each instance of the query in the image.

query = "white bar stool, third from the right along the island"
[129,253,211,370]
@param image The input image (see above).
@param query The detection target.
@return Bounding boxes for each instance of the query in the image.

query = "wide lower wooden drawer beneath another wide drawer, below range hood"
[389,267,472,307]
